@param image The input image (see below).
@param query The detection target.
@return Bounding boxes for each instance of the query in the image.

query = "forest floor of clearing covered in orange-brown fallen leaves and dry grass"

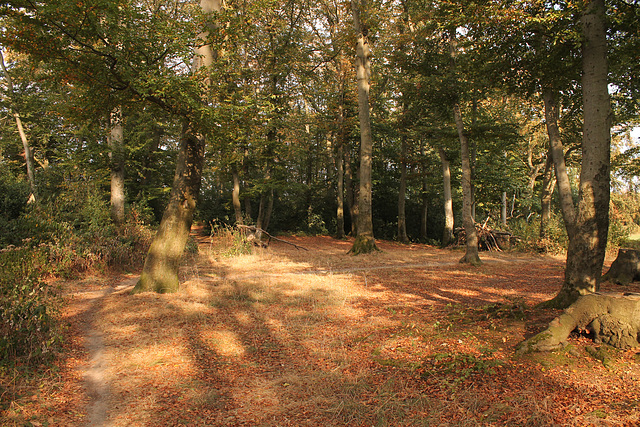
[0,232,640,426]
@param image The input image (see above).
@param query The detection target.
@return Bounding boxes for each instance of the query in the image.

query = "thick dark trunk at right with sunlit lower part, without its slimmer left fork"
[553,0,611,307]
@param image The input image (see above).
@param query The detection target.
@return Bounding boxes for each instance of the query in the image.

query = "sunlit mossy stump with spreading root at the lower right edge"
[516,294,640,353]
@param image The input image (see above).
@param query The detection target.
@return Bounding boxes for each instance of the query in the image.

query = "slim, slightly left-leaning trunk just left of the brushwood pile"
[453,103,481,265]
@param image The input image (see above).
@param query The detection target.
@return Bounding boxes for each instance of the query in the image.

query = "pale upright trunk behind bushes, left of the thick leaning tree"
[108,107,125,232]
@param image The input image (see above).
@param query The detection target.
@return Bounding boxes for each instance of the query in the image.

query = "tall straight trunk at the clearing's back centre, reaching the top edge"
[349,0,378,255]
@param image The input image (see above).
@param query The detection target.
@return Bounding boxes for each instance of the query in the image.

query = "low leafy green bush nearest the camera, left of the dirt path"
[0,247,62,365]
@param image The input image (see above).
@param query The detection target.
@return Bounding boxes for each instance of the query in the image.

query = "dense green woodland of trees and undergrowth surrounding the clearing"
[0,0,640,392]
